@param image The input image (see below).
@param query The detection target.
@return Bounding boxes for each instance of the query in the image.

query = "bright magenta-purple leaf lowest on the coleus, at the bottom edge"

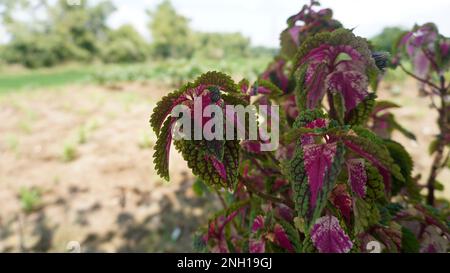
[311,215,353,253]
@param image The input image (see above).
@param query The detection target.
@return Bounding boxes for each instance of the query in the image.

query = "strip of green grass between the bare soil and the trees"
[0,56,271,94]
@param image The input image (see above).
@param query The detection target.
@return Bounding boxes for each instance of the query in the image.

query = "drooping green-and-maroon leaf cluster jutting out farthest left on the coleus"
[150,71,249,187]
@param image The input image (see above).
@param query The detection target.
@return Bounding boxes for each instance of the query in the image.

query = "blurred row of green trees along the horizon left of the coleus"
[0,0,273,68]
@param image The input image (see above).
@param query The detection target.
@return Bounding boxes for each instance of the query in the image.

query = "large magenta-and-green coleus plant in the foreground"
[151,1,450,253]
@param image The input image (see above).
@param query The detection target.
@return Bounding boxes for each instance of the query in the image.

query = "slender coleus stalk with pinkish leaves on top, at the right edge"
[393,23,450,206]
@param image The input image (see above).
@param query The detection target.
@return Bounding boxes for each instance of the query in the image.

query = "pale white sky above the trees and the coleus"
[0,0,450,47]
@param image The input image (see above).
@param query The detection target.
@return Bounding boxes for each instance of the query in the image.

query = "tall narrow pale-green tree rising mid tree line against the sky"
[147,0,195,58]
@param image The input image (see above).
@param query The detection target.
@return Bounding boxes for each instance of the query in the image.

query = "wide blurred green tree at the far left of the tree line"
[0,0,115,67]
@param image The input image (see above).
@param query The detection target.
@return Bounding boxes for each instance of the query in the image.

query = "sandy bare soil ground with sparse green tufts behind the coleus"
[0,78,450,252]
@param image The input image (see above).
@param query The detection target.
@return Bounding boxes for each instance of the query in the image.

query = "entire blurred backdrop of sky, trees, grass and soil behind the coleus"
[0,0,450,252]
